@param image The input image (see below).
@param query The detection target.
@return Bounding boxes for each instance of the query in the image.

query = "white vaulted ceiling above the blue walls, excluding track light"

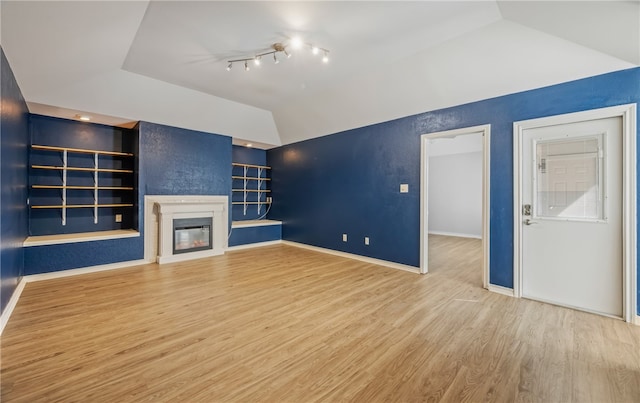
[0,0,640,147]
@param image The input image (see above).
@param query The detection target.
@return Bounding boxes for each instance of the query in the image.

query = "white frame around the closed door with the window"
[513,104,637,323]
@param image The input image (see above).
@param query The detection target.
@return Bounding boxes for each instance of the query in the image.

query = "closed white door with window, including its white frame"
[514,104,636,322]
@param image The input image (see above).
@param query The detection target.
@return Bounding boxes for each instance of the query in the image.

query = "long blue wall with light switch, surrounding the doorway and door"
[267,68,640,310]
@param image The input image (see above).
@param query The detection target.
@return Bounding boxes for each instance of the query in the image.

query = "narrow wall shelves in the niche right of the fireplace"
[231,162,271,215]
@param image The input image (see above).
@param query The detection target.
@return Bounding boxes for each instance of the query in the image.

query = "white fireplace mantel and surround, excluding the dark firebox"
[145,196,229,264]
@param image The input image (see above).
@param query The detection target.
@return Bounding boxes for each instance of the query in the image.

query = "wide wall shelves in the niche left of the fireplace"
[30,144,135,225]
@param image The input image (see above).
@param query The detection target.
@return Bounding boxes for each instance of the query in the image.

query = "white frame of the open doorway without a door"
[420,124,491,288]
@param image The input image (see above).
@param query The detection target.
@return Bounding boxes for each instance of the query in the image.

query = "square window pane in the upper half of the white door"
[534,135,604,220]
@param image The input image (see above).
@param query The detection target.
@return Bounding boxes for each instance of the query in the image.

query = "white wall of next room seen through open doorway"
[428,134,482,238]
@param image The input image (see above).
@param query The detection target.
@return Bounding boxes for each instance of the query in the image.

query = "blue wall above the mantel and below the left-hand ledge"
[25,122,231,274]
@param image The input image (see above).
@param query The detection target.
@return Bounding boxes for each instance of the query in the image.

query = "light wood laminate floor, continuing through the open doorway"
[0,237,640,402]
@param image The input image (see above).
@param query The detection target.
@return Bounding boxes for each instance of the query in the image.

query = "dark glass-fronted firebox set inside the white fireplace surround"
[173,217,213,255]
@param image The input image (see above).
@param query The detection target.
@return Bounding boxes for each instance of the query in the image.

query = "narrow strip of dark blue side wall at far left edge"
[0,47,29,312]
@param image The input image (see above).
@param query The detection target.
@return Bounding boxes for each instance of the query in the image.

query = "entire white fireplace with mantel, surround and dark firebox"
[144,195,229,264]
